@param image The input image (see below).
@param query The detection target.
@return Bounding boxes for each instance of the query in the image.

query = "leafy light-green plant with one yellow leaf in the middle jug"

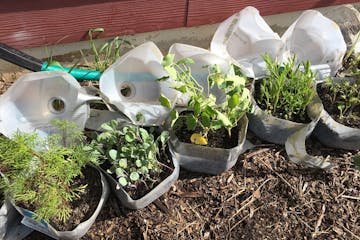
[159,54,251,145]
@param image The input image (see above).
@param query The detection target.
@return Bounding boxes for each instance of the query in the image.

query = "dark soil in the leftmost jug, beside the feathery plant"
[26,167,102,239]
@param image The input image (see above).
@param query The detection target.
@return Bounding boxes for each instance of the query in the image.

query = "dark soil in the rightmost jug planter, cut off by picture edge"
[317,84,360,128]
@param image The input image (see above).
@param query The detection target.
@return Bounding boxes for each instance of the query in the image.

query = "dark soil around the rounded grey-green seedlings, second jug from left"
[104,150,175,200]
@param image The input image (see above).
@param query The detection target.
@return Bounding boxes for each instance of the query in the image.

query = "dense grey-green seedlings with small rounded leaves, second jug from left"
[96,120,169,186]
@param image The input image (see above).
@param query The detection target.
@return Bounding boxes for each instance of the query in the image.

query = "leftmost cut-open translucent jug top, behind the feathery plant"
[0,72,100,140]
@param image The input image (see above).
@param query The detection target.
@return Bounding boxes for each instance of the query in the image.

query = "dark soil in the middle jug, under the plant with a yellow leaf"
[175,117,240,149]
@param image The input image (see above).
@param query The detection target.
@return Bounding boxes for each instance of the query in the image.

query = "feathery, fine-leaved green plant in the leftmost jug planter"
[0,121,97,222]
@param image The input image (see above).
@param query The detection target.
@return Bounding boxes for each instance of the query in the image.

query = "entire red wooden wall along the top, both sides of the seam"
[0,0,358,49]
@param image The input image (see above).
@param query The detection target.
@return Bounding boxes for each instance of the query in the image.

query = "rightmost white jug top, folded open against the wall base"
[282,10,346,75]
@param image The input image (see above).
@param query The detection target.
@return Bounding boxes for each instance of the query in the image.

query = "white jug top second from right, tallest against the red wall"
[210,7,284,78]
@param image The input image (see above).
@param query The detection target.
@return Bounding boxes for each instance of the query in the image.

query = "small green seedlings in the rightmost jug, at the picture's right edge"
[323,78,360,119]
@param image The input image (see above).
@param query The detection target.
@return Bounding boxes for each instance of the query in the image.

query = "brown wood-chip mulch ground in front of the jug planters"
[23,134,360,240]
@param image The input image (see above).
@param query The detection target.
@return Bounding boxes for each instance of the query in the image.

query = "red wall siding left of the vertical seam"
[0,0,187,48]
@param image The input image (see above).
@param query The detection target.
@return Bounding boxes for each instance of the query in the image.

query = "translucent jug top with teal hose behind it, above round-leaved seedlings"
[100,42,178,126]
